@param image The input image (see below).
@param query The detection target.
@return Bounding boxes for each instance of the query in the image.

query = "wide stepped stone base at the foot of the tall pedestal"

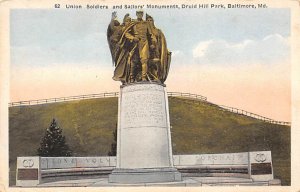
[109,168,181,184]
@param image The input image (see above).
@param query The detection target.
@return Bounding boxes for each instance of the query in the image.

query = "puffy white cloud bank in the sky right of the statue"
[193,34,290,64]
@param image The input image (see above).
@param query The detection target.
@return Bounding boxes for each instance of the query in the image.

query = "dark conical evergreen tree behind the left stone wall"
[37,119,72,157]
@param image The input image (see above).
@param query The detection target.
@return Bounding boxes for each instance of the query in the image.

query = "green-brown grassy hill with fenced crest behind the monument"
[9,97,291,185]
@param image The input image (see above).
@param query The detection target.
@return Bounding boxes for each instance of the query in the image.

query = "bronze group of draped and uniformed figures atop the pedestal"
[107,10,171,84]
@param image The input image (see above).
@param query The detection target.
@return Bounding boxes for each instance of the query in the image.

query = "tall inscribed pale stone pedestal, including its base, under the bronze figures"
[109,82,181,183]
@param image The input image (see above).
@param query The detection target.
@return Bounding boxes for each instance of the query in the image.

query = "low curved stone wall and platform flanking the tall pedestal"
[16,151,281,187]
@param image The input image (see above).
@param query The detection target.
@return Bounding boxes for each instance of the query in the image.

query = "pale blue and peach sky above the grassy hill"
[10,9,291,121]
